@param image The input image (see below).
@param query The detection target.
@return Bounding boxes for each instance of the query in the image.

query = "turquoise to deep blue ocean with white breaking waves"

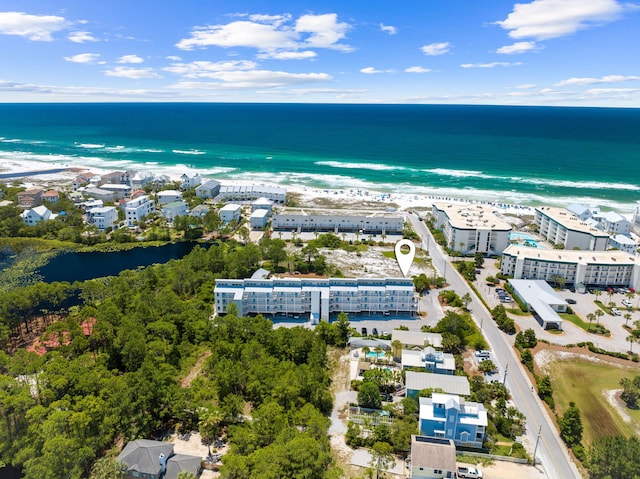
[0,103,640,213]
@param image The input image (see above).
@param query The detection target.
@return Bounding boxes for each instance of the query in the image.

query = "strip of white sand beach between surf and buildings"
[0,159,640,217]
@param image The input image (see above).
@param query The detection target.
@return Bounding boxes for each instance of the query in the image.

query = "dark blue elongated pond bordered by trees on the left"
[38,242,199,283]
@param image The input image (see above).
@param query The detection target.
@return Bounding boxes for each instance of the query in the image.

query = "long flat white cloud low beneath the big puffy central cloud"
[171,70,332,90]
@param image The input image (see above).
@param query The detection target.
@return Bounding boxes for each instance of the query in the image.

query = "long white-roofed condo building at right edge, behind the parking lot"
[500,245,640,289]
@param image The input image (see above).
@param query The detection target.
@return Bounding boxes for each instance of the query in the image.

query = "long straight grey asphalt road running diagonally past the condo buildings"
[407,214,582,479]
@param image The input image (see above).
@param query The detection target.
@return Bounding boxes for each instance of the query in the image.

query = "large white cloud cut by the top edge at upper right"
[496,0,626,40]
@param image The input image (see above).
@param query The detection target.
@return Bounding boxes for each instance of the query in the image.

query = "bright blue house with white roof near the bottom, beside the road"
[419,393,488,448]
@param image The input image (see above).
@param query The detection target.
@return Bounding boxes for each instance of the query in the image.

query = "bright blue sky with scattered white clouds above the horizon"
[0,0,640,107]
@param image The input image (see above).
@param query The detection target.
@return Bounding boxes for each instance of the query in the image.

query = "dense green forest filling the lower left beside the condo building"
[0,240,346,479]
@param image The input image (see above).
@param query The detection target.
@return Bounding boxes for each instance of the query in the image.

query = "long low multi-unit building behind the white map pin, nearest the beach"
[271,213,404,235]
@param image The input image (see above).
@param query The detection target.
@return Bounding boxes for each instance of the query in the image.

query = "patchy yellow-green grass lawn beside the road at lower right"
[550,359,640,446]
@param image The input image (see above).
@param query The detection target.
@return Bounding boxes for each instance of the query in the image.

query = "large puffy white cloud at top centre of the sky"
[176,13,351,52]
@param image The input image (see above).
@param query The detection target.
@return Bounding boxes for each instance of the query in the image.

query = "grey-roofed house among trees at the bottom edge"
[116,439,202,479]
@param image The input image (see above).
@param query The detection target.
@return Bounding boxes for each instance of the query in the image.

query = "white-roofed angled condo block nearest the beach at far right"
[535,206,609,251]
